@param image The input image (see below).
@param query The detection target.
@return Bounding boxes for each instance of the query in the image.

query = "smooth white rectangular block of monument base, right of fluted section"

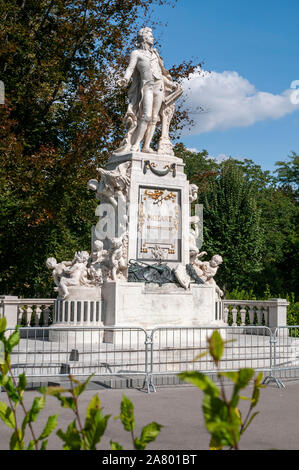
[102,281,223,330]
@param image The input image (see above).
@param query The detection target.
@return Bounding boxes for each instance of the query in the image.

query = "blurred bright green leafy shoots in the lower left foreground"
[0,318,162,450]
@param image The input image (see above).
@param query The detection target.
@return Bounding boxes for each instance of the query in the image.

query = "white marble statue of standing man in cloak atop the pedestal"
[115,28,182,155]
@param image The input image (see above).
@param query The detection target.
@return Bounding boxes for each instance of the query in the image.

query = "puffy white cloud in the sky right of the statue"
[183,71,299,135]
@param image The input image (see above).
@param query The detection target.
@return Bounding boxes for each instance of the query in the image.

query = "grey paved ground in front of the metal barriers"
[0,382,299,450]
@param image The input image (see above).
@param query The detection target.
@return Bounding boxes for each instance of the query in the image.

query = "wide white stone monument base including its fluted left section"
[49,281,225,344]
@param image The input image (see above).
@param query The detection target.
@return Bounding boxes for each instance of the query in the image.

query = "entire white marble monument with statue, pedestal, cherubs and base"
[47,28,223,341]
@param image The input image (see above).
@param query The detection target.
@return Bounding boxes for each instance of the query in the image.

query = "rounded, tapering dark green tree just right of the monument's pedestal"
[199,159,264,290]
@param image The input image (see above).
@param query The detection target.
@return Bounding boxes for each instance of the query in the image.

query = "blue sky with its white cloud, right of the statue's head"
[150,0,299,170]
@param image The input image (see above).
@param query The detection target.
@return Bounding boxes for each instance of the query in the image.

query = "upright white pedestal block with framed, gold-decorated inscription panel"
[94,152,190,267]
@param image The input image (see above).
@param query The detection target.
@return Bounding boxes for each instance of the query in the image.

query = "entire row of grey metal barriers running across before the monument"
[1,326,299,392]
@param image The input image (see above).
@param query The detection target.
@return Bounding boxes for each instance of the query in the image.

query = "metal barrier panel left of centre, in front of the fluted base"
[3,327,149,388]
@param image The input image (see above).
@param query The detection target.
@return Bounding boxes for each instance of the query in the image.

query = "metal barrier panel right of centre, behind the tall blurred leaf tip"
[150,326,273,385]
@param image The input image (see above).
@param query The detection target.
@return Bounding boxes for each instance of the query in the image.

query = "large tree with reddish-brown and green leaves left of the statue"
[0,0,204,296]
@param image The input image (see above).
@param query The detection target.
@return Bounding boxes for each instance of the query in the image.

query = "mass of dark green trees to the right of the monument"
[175,144,299,299]
